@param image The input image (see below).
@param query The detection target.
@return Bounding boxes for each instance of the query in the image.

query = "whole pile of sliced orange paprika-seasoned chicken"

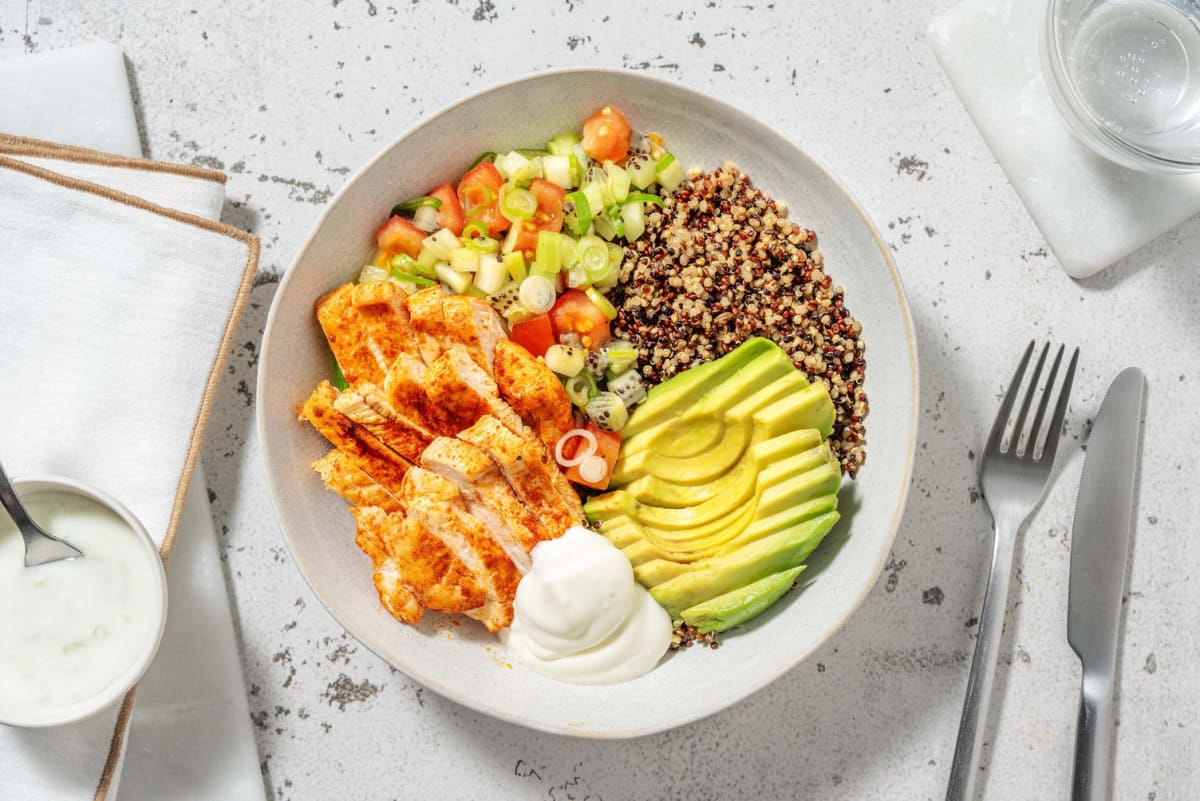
[300,282,582,631]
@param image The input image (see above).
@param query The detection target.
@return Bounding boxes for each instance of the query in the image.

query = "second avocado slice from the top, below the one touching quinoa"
[622,348,808,458]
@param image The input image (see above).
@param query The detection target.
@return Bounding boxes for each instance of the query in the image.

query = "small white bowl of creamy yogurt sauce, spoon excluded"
[0,478,167,727]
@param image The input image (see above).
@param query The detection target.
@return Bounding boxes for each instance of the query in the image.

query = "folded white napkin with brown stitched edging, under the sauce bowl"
[0,134,258,801]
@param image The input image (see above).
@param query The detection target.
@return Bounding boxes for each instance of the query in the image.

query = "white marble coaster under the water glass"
[928,0,1200,278]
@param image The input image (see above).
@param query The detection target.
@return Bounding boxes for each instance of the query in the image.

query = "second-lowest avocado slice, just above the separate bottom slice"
[650,512,838,618]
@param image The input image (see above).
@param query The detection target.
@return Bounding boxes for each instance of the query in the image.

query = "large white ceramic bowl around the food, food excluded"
[258,71,918,737]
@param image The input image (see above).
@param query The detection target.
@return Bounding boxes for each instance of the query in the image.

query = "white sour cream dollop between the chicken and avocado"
[500,526,672,685]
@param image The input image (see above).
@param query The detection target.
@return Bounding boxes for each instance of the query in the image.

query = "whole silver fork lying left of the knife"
[946,342,1079,801]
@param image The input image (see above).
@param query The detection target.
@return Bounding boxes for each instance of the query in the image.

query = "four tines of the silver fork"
[988,342,1079,462]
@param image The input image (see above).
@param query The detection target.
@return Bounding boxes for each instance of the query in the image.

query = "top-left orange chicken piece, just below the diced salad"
[317,281,419,386]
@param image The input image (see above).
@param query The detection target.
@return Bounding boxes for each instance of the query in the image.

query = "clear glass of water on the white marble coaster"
[1042,0,1200,173]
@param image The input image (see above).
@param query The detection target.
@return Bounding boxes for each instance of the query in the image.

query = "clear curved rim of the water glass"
[1042,0,1200,174]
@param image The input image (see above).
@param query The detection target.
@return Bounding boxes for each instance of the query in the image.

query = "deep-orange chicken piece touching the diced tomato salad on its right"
[496,339,575,451]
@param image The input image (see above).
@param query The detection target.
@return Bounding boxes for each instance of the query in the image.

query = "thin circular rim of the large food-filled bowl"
[254,67,920,740]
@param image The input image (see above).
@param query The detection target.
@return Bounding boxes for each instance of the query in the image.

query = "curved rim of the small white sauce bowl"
[0,474,167,729]
